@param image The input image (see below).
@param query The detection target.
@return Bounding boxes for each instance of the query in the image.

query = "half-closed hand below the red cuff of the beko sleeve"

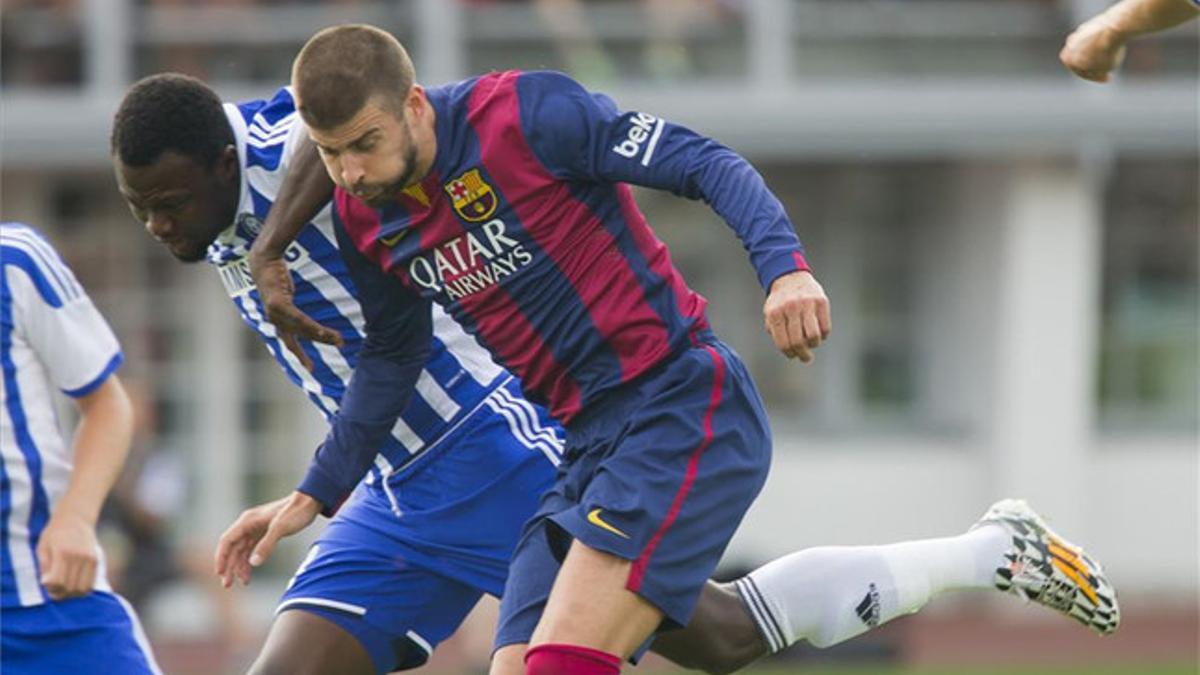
[762,271,833,363]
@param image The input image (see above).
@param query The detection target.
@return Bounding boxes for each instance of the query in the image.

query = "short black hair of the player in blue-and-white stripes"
[110,73,234,168]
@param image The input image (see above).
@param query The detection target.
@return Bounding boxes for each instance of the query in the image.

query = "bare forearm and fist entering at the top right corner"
[1058,0,1200,82]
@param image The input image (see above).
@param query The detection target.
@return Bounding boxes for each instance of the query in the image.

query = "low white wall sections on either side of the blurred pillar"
[726,437,1200,590]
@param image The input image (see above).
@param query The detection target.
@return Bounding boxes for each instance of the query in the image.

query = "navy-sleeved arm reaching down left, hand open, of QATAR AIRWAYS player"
[228,197,433,571]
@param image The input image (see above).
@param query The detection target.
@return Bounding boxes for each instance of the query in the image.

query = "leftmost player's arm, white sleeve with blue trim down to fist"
[5,249,133,599]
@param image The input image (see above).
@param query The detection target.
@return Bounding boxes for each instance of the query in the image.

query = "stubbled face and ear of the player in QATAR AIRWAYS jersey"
[308,85,425,207]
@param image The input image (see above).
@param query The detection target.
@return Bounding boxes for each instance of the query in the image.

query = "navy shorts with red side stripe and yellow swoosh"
[496,331,770,649]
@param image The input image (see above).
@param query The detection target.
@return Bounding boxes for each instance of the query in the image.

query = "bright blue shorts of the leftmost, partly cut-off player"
[0,591,160,675]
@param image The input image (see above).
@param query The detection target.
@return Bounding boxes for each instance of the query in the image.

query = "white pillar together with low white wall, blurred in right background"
[728,160,1200,595]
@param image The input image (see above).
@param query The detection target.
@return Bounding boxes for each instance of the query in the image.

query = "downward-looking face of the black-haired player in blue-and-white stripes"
[113,145,240,263]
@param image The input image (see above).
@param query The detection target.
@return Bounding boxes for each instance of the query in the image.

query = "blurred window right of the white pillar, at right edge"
[1098,157,1200,434]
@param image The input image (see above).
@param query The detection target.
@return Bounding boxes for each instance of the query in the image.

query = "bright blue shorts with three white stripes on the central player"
[277,383,562,673]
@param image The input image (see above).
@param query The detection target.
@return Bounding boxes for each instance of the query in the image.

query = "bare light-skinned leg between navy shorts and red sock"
[530,540,662,658]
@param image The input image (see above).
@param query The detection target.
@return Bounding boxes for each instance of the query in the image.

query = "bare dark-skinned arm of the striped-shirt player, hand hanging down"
[247,130,342,370]
